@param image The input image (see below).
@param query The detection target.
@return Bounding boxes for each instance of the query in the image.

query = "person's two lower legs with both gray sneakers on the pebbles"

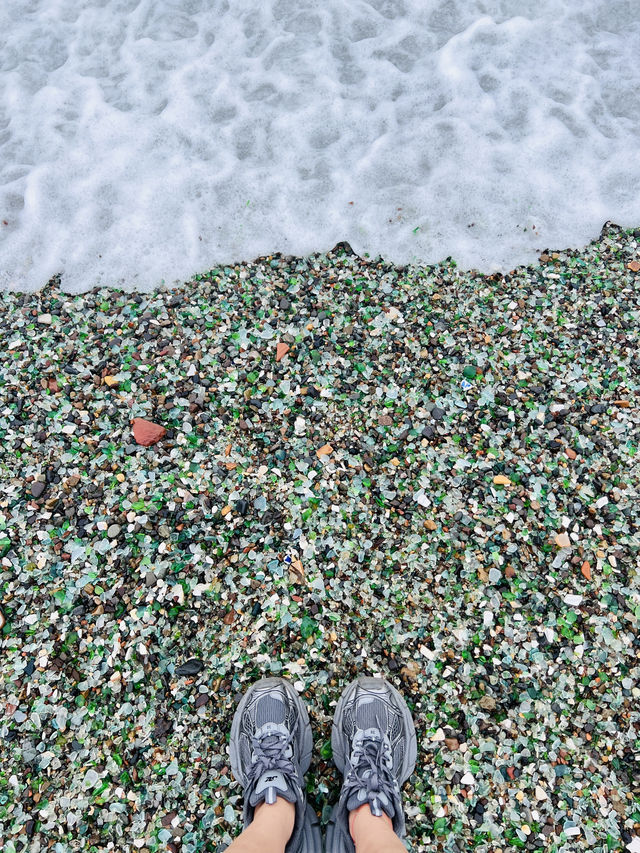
[228,678,416,853]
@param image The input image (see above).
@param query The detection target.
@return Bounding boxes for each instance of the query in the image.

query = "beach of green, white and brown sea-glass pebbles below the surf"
[0,224,640,853]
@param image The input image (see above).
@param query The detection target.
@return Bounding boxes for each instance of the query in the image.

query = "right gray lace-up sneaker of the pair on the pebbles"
[325,677,417,853]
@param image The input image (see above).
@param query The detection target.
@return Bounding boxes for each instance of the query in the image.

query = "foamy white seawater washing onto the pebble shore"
[0,0,640,292]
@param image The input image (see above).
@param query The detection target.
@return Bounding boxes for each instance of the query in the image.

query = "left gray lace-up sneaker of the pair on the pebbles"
[229,678,322,853]
